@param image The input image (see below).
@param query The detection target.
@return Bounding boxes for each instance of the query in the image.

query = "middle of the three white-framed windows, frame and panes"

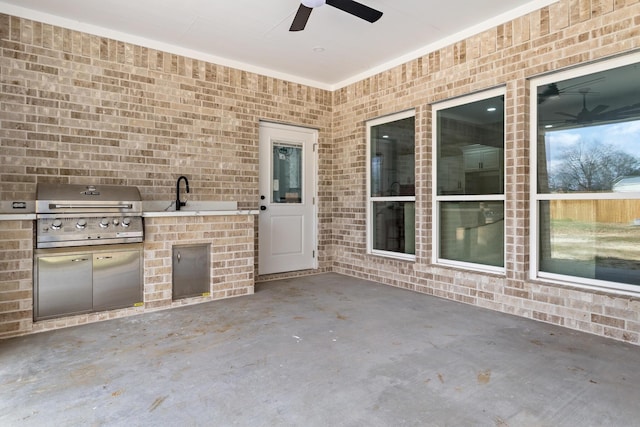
[433,89,504,272]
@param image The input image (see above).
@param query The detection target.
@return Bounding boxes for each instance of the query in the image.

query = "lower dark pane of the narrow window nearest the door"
[373,202,416,254]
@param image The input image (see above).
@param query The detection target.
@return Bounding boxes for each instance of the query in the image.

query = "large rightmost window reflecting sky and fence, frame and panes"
[531,54,640,291]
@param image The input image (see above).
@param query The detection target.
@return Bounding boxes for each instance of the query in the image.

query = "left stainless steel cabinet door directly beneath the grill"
[34,253,93,320]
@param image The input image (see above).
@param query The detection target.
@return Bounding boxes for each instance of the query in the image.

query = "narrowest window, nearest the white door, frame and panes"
[367,110,416,260]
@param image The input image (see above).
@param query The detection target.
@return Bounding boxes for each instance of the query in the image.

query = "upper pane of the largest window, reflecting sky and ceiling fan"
[537,64,640,193]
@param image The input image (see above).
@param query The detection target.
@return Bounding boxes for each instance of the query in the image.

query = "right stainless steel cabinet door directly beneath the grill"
[93,251,142,310]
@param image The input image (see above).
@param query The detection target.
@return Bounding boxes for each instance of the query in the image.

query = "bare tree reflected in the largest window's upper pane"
[549,142,640,192]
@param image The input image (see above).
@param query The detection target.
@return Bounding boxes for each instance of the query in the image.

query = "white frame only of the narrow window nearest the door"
[366,108,417,262]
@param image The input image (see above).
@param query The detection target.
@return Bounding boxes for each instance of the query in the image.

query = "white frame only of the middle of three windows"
[431,86,507,275]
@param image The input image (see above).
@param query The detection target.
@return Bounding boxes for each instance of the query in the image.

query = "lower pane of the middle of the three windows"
[440,201,504,267]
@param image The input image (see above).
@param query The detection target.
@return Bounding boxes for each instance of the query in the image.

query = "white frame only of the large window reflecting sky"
[529,52,640,295]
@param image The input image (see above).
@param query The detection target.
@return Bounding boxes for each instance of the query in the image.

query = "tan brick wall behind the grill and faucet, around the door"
[0,14,332,282]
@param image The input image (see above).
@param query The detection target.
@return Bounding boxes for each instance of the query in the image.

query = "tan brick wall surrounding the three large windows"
[332,0,640,344]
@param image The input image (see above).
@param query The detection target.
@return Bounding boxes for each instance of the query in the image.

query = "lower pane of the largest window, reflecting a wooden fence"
[539,200,640,285]
